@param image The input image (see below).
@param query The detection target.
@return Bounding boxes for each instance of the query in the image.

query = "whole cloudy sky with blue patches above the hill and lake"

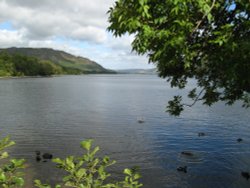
[0,0,153,69]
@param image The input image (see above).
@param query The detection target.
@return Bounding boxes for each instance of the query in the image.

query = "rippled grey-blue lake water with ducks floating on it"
[0,75,250,188]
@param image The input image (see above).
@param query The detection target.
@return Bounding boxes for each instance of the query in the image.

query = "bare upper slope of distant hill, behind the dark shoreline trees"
[0,47,115,74]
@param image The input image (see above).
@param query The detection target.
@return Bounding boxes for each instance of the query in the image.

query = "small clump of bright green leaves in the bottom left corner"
[0,137,24,188]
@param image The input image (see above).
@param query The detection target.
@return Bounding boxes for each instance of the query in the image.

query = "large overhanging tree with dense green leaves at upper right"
[108,0,250,115]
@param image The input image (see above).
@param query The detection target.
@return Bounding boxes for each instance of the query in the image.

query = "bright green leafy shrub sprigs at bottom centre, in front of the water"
[35,140,142,188]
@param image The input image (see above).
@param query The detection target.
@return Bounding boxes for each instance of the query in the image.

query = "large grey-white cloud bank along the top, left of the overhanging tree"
[0,0,111,42]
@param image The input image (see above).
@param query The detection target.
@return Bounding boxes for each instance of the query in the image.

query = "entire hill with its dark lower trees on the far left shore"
[0,48,115,77]
